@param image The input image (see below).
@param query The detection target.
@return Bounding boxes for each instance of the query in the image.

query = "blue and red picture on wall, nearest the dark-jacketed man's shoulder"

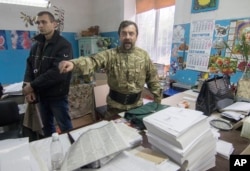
[11,30,32,49]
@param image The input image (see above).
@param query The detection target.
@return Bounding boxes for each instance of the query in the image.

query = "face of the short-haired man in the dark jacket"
[36,14,56,35]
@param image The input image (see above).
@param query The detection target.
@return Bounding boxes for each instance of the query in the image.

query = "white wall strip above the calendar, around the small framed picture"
[174,0,250,24]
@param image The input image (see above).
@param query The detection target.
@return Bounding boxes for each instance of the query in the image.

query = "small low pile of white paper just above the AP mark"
[216,140,234,160]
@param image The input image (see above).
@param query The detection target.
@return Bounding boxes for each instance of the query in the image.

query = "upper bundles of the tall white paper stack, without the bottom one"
[143,107,210,149]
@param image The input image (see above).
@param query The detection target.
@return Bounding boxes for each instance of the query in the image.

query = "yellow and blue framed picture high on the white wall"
[191,0,219,13]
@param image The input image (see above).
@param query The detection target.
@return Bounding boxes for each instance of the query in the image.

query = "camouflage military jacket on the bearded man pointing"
[71,47,162,110]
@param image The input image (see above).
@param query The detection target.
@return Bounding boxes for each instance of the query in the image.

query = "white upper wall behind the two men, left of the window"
[0,0,135,32]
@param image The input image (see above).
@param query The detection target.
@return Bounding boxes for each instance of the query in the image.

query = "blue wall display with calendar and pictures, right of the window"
[170,18,250,83]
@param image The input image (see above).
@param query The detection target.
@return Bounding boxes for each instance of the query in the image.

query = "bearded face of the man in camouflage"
[119,25,137,50]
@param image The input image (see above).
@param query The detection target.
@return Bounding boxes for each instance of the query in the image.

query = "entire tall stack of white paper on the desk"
[143,107,216,171]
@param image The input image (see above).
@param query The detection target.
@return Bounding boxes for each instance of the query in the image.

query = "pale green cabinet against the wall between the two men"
[78,37,103,56]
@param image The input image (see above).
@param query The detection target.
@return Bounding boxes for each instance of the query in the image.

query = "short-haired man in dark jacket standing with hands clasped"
[23,11,73,137]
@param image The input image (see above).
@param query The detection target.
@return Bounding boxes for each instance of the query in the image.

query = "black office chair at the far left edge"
[0,100,21,140]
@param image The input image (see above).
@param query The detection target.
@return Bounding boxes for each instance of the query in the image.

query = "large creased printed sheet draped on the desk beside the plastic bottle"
[61,122,130,171]
